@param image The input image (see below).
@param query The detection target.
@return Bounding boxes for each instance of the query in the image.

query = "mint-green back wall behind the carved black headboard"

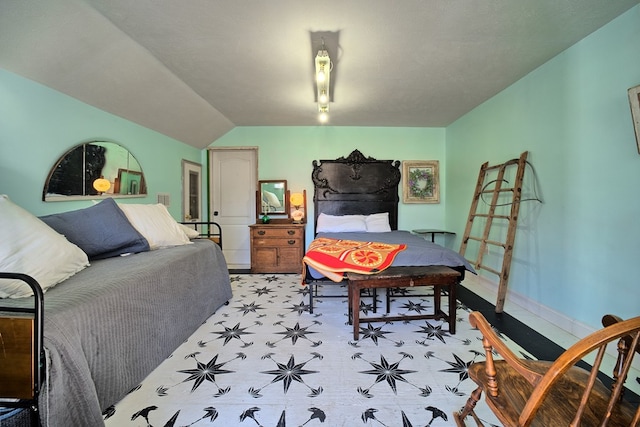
[212,126,448,244]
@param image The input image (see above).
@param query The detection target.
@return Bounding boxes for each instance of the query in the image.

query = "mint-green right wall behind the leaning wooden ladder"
[446,6,640,327]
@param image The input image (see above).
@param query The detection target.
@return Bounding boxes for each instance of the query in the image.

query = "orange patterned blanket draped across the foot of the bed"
[302,237,407,282]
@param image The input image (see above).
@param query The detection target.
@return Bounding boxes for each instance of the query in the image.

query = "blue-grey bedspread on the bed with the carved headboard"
[309,230,475,279]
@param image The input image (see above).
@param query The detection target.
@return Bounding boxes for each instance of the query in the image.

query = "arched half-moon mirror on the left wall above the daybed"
[42,141,147,202]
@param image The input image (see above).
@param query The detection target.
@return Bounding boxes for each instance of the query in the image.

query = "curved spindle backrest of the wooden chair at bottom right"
[519,316,640,426]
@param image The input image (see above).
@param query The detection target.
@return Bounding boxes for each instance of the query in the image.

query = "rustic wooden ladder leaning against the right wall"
[460,151,528,313]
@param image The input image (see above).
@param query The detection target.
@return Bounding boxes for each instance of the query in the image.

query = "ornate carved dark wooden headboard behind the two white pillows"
[311,150,400,230]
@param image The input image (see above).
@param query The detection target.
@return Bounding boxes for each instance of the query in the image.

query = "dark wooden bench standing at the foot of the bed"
[347,265,462,340]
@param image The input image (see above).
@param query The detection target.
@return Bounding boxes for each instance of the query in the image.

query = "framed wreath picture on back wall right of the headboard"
[402,160,440,203]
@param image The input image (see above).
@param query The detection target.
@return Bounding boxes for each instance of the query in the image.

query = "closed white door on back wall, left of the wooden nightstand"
[209,147,258,269]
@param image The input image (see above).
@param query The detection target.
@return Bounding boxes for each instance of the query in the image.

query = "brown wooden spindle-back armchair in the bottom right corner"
[454,312,640,427]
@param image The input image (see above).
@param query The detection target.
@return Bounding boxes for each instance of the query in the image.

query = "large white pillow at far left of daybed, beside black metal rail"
[0,194,89,298]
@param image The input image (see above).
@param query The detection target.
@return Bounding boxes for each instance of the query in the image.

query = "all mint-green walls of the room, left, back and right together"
[0,6,640,327]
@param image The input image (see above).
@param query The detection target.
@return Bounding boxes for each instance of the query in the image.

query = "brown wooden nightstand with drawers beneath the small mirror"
[249,223,305,273]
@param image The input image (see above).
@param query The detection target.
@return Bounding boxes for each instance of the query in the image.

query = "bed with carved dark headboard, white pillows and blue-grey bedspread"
[304,150,474,338]
